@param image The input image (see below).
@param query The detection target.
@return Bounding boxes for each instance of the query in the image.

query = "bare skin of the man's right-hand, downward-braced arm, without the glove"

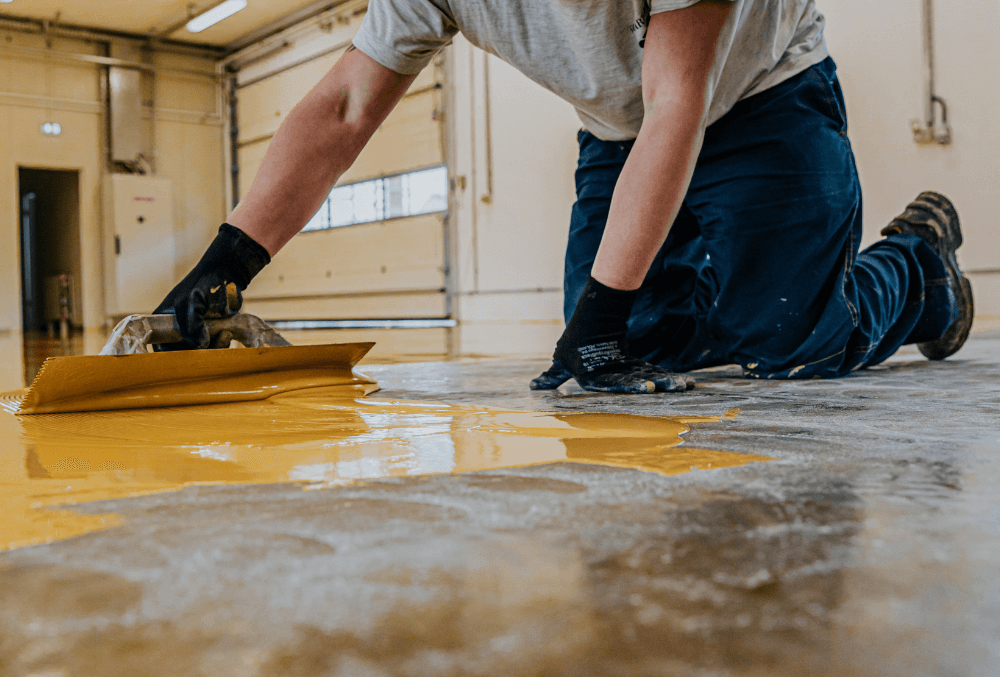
[591,2,732,290]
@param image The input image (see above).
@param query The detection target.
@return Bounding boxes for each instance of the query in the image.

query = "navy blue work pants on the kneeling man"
[564,59,957,378]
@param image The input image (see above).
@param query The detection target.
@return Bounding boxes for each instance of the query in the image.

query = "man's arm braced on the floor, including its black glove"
[531,2,731,393]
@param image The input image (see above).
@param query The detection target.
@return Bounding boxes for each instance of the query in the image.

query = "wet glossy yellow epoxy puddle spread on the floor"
[0,385,770,550]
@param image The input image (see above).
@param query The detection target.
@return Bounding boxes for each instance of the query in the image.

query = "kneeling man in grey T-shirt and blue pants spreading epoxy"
[158,0,972,393]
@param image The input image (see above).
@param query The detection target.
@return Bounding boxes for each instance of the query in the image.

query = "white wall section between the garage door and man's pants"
[448,37,580,354]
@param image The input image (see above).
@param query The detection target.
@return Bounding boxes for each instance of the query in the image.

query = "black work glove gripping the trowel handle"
[153,223,271,351]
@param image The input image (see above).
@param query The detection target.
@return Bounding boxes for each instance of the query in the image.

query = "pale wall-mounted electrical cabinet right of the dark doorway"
[104,174,177,318]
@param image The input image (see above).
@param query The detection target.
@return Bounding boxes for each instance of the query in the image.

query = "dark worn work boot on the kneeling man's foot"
[882,190,974,360]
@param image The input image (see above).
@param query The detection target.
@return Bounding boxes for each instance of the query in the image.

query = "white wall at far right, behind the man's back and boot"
[819,0,1000,315]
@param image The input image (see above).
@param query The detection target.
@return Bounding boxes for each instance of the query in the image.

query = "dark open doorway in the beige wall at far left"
[17,167,82,332]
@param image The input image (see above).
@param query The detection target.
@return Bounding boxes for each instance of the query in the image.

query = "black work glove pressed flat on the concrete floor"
[531,277,694,393]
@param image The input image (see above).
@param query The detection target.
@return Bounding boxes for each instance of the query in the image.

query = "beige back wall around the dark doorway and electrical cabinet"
[0,31,225,330]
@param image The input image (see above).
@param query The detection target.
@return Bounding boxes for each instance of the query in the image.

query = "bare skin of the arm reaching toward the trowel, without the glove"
[229,46,417,256]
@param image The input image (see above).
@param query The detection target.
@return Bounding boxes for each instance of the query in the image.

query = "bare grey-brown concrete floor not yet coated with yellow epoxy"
[0,333,1000,677]
